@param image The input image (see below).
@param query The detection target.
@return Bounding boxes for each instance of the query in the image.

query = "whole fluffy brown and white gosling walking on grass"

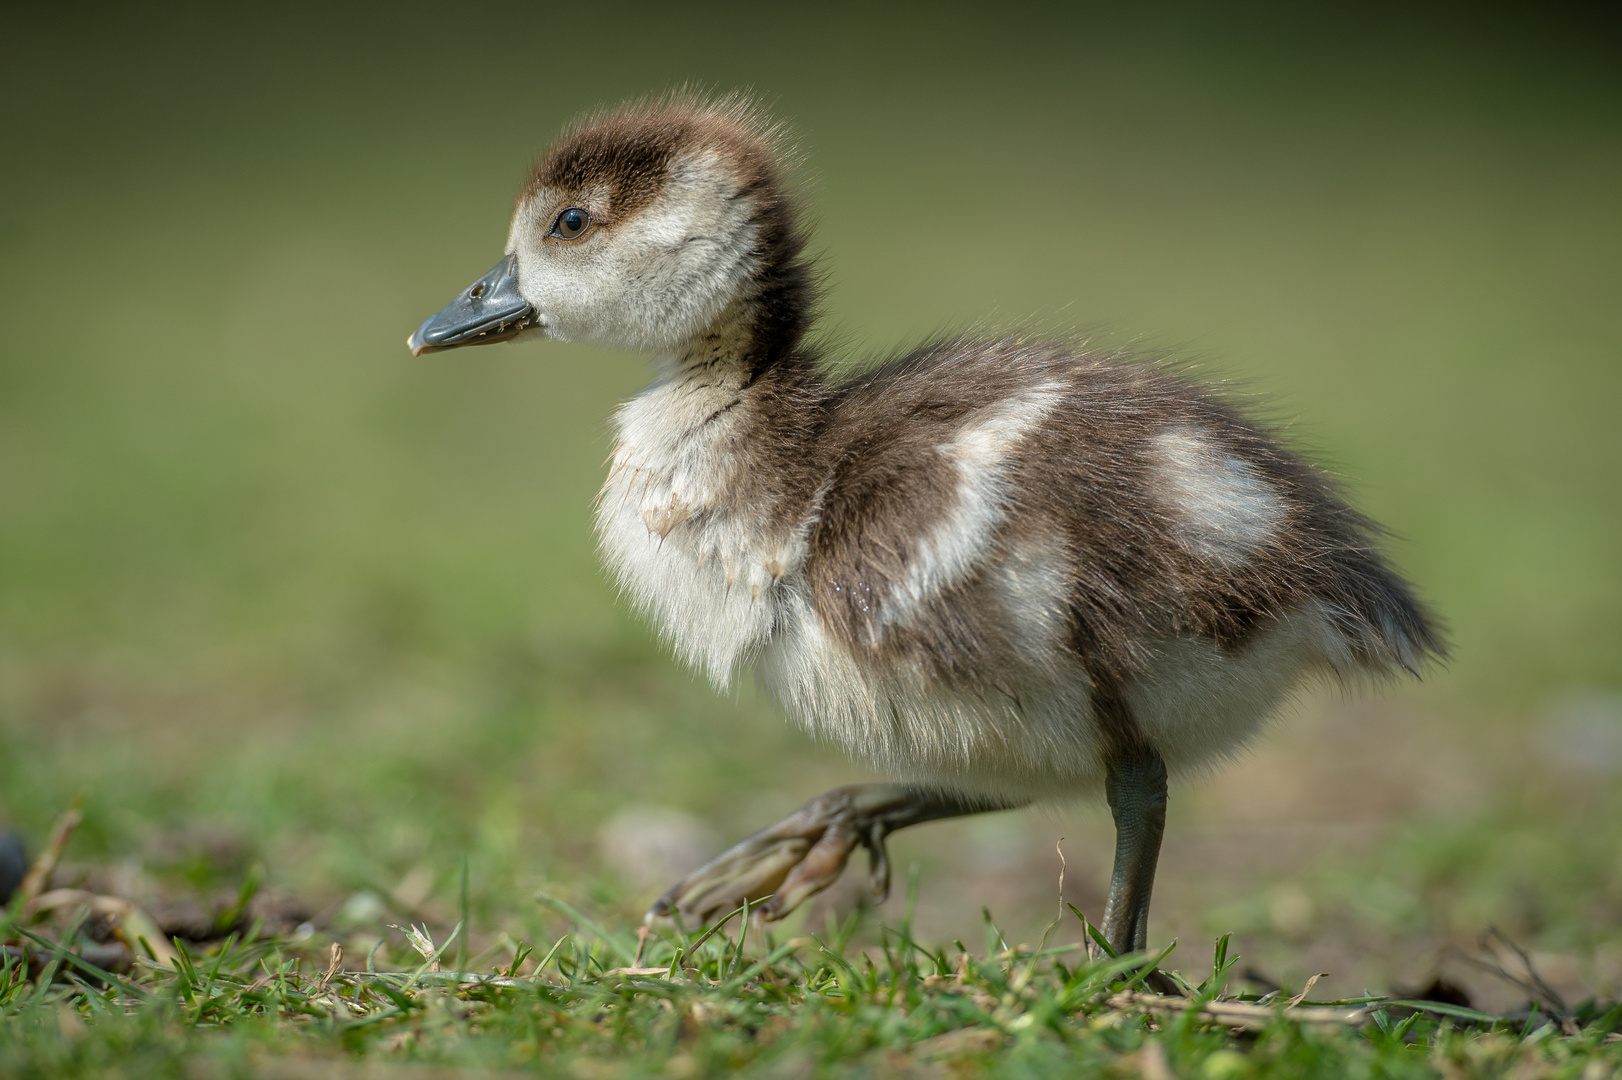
[409,97,1444,954]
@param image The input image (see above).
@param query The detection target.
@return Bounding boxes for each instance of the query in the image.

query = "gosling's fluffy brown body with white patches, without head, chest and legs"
[742,339,1440,786]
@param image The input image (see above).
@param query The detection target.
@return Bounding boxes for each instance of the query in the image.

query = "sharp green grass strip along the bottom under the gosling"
[0,888,1622,1080]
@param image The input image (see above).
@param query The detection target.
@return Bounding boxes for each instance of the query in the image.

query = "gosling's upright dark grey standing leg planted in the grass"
[1103,744,1166,954]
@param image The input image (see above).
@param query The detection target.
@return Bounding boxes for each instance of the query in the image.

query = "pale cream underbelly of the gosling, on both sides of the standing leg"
[756,595,1338,798]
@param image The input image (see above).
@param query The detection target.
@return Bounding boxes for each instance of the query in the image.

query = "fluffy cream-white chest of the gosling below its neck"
[597,377,805,684]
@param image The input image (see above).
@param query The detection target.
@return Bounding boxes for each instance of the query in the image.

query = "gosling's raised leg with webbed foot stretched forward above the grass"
[647,783,1014,924]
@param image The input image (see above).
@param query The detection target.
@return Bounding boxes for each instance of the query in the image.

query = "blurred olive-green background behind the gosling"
[0,3,1622,994]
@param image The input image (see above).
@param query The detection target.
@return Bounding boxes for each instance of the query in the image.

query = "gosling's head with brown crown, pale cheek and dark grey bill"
[409,99,809,355]
